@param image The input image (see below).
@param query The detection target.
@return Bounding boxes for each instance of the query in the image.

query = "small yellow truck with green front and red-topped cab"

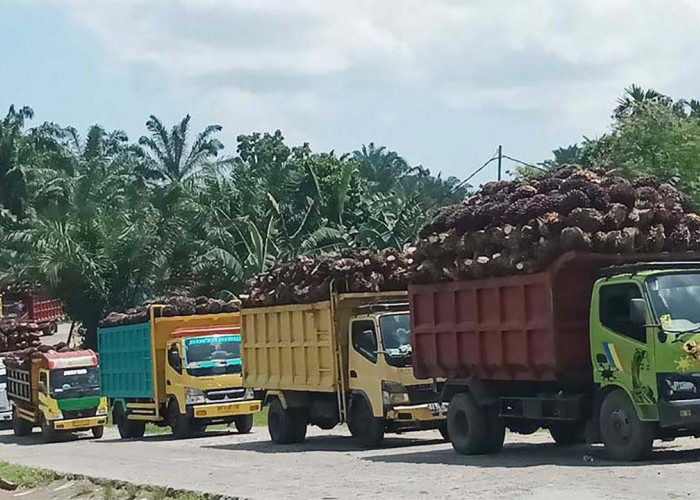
[6,350,107,442]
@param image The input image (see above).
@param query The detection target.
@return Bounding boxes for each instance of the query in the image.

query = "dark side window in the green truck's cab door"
[600,283,646,343]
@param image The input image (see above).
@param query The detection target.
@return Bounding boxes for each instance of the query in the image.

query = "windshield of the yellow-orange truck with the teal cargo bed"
[185,335,241,377]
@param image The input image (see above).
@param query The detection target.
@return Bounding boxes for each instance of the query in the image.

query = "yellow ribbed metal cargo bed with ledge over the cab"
[241,292,407,392]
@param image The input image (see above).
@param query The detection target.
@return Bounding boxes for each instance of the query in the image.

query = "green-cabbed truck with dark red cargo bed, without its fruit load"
[409,252,700,461]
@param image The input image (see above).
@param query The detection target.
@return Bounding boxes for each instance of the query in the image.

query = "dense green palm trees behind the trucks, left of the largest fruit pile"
[0,108,466,346]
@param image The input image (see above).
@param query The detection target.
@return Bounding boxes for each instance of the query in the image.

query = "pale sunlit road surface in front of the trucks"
[0,428,700,500]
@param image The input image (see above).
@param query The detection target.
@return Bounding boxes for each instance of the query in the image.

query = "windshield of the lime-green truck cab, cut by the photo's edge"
[647,273,700,332]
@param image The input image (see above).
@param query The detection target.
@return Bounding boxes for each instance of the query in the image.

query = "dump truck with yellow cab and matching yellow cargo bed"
[241,292,447,447]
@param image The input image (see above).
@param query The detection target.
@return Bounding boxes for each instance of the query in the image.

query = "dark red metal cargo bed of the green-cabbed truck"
[409,252,698,381]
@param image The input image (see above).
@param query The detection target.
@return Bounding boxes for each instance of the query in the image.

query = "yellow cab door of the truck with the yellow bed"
[348,319,384,417]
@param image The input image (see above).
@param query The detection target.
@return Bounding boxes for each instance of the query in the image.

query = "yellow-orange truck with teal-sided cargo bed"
[98,305,261,438]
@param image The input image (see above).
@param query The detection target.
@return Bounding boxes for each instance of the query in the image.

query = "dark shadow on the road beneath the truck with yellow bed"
[205,434,446,453]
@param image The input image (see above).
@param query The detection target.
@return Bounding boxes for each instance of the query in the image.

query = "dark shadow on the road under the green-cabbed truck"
[361,443,700,468]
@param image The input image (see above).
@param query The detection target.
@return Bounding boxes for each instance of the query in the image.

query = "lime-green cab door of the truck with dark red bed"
[591,281,657,420]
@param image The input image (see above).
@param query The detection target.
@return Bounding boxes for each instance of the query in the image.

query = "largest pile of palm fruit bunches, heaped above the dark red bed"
[411,166,700,283]
